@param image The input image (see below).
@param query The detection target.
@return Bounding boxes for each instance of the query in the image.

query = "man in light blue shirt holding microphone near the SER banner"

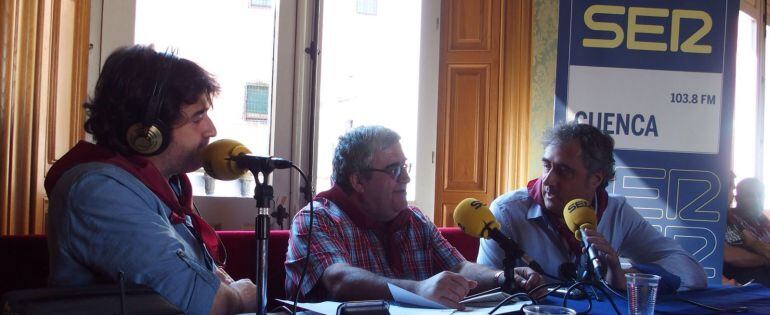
[477,123,706,291]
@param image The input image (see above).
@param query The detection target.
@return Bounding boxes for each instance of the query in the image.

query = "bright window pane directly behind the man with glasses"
[316,0,426,202]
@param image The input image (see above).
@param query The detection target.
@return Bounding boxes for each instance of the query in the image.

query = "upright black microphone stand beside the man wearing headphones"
[244,160,275,315]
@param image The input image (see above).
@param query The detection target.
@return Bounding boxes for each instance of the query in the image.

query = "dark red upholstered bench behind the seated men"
[0,228,479,309]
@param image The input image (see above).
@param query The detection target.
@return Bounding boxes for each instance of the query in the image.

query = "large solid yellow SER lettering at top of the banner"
[583,4,713,54]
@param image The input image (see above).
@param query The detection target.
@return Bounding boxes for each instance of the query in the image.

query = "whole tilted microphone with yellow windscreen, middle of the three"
[452,198,545,274]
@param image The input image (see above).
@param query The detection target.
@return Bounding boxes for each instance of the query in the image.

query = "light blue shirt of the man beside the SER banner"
[477,189,706,289]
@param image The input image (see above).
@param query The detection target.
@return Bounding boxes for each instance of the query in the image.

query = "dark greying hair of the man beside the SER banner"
[542,121,615,188]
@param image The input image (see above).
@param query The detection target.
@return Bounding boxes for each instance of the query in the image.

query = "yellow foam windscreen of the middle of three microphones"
[452,198,500,239]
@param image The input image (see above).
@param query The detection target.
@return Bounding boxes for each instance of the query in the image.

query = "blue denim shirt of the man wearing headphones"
[48,163,220,314]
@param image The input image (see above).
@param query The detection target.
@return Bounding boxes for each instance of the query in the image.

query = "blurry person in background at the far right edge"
[722,178,770,287]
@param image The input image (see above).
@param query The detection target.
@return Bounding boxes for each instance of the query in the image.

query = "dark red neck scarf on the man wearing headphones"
[44,141,223,265]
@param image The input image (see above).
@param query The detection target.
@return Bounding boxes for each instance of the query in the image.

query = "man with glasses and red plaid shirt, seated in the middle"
[286,126,541,309]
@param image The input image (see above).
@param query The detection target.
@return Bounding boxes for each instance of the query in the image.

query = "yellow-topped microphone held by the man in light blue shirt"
[564,199,602,280]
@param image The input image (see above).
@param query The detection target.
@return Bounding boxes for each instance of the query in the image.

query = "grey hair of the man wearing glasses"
[332,126,401,192]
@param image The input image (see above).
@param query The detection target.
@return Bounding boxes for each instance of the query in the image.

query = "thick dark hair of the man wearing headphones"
[83,45,219,155]
